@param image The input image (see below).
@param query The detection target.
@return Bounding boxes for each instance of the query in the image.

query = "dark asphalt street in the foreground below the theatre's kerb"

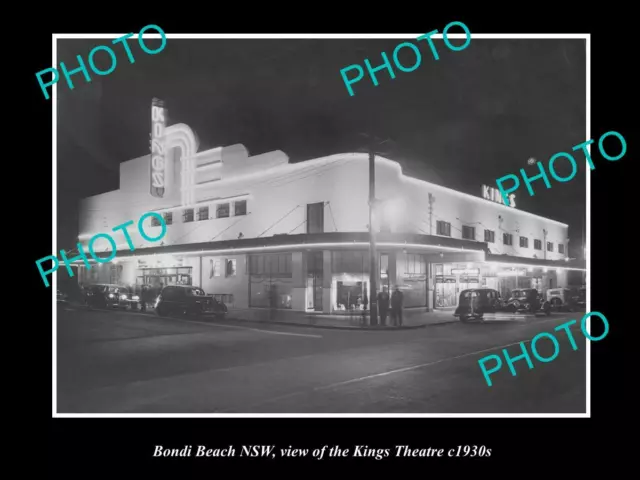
[56,307,586,414]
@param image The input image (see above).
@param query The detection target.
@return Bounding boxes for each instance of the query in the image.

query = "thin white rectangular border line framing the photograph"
[50,33,591,418]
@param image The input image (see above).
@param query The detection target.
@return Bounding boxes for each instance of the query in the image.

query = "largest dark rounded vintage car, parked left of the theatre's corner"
[155,285,227,317]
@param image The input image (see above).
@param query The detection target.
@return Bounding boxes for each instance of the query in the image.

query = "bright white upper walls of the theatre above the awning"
[80,146,568,260]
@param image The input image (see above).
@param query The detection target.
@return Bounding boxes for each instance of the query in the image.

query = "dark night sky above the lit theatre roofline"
[58,38,586,257]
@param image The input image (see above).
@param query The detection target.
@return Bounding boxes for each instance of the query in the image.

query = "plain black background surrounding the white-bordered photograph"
[13,7,638,478]
